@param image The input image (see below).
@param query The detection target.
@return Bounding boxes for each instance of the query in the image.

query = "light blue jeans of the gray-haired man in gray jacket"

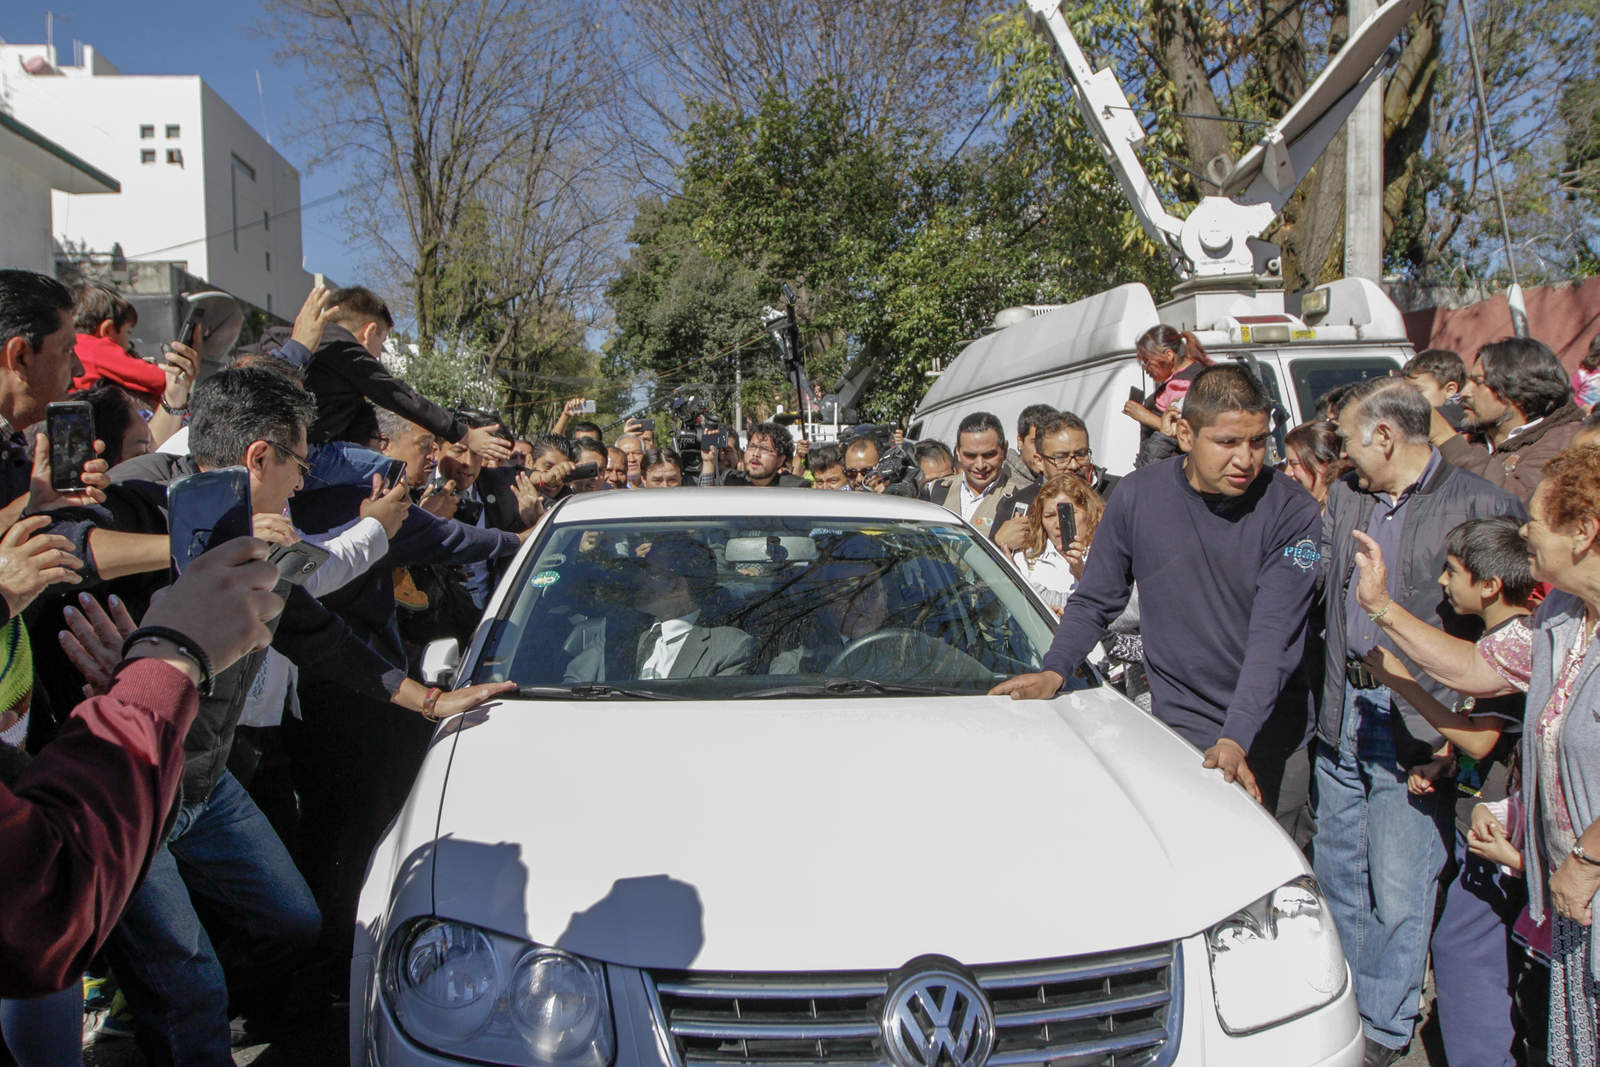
[1312,685,1453,1048]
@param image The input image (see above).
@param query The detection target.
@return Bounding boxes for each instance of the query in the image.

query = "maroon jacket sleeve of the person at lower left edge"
[0,659,200,997]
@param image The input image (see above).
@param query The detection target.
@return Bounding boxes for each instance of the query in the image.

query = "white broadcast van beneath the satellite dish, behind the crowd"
[907,278,1413,474]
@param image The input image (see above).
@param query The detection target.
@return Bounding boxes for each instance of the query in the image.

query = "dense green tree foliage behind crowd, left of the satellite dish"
[608,14,1168,419]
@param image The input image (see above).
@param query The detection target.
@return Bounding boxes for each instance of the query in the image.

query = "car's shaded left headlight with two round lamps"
[382,918,616,1067]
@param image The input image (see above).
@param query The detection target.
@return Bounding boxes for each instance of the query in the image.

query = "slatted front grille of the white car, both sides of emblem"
[646,944,1182,1067]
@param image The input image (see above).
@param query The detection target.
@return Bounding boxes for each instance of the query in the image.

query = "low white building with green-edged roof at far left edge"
[0,112,118,275]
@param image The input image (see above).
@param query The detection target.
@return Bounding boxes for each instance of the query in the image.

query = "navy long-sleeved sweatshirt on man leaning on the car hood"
[1043,456,1322,750]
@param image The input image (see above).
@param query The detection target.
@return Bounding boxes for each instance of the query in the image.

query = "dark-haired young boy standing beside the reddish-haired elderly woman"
[1357,517,1536,1064]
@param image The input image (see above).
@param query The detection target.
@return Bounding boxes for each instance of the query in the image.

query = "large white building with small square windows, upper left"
[0,45,310,318]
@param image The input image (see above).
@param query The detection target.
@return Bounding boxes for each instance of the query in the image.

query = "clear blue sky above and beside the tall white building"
[0,0,366,283]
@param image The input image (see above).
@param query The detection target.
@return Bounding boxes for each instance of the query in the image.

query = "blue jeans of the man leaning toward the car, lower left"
[106,771,322,1067]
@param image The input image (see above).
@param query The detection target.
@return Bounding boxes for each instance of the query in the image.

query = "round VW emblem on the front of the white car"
[878,957,995,1067]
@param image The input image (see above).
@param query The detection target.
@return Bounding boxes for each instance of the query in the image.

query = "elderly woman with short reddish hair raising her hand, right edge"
[1357,445,1600,1067]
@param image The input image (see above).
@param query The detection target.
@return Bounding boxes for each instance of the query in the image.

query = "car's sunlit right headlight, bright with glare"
[1205,875,1349,1033]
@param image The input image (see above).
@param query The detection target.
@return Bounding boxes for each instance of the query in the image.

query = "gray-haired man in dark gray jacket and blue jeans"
[1314,378,1525,1067]
